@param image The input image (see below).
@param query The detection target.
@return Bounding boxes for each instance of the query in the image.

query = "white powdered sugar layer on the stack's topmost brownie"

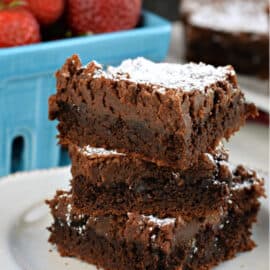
[102,57,235,94]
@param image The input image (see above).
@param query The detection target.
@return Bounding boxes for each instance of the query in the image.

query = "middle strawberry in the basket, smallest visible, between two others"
[26,0,64,25]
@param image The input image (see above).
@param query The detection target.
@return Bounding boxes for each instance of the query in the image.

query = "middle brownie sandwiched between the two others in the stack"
[69,143,230,217]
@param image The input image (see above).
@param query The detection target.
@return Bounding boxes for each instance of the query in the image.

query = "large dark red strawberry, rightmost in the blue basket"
[67,0,141,34]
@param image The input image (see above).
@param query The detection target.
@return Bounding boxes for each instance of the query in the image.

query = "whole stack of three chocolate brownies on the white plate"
[48,55,264,270]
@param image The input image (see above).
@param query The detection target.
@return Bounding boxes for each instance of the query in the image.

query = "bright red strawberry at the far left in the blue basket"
[0,7,40,48]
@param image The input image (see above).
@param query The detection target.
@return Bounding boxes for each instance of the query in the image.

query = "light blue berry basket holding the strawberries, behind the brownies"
[0,12,171,176]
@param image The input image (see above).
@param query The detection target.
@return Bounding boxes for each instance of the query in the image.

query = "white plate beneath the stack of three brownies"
[0,168,269,270]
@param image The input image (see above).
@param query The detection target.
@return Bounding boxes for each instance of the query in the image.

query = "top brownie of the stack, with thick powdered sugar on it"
[49,55,257,169]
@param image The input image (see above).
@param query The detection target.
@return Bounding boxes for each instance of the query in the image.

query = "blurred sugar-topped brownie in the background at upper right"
[180,0,269,78]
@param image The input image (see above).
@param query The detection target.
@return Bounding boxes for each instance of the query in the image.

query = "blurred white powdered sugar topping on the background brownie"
[188,0,268,35]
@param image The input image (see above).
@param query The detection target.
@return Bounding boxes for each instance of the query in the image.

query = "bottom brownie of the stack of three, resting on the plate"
[48,167,264,270]
